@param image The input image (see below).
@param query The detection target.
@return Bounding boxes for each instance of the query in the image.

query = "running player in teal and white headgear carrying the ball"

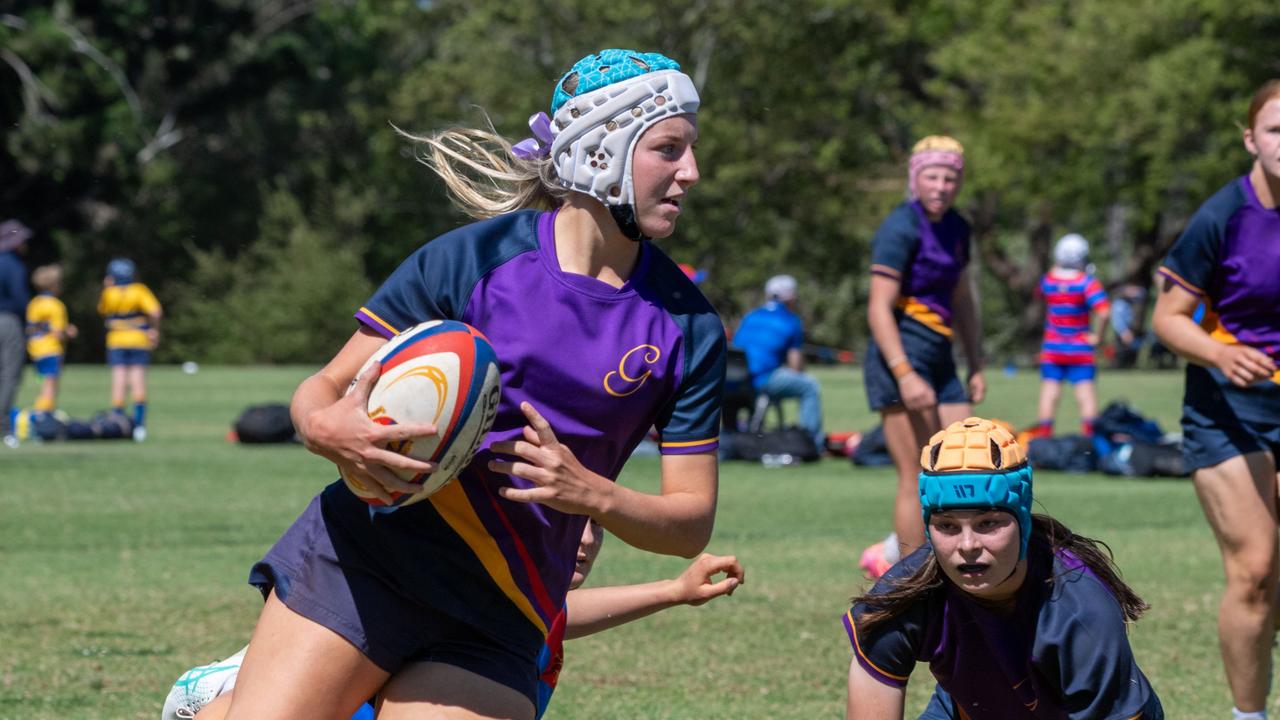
[213,50,724,719]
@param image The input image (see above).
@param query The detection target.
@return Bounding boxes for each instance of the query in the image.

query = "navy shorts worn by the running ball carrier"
[248,496,540,707]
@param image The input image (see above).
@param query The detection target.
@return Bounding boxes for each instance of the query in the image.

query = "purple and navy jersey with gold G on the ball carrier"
[345,210,726,644]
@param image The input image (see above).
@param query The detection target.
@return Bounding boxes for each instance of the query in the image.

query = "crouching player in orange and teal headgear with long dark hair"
[844,418,1164,720]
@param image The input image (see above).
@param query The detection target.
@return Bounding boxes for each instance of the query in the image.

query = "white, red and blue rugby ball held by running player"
[342,320,502,507]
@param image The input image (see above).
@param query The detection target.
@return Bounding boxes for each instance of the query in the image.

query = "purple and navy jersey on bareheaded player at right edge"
[1160,176,1280,382]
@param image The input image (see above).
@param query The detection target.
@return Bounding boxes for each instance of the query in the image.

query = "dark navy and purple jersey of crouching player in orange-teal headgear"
[844,539,1160,720]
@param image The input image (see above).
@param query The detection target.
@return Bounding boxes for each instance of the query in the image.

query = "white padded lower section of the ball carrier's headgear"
[552,70,699,206]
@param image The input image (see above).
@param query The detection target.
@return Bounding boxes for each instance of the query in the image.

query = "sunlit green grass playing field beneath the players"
[0,366,1249,720]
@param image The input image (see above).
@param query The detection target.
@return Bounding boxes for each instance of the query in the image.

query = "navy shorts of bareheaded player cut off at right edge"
[1183,364,1280,470]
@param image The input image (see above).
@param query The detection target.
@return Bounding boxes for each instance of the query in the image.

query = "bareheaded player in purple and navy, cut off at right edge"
[1152,79,1280,720]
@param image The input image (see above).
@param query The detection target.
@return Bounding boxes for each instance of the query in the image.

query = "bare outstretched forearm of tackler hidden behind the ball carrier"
[564,552,746,639]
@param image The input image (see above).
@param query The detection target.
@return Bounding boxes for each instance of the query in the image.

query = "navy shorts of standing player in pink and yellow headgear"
[863,319,969,410]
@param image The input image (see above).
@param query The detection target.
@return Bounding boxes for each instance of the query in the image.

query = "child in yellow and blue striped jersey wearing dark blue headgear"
[97,258,161,441]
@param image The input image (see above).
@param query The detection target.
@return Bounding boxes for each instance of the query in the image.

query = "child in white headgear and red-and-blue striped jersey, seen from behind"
[1036,233,1111,437]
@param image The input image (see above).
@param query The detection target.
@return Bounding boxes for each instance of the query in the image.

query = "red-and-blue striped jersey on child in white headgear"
[1039,270,1110,365]
